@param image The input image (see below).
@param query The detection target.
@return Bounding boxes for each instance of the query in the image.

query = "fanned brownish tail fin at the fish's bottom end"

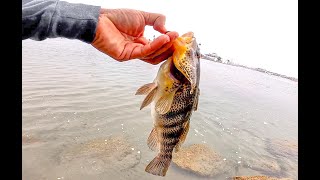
[145,154,171,176]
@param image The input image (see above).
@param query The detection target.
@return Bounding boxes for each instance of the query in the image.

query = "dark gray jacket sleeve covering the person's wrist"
[22,0,101,43]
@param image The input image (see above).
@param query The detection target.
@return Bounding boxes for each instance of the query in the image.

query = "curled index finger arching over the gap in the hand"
[142,12,167,34]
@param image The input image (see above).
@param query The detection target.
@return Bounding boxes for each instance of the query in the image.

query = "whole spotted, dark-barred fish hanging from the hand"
[136,32,200,176]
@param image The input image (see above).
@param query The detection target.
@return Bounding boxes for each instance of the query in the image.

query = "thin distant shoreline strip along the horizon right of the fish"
[201,53,298,82]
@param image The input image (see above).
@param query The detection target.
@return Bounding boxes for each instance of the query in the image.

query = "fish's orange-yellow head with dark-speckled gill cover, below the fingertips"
[172,32,201,93]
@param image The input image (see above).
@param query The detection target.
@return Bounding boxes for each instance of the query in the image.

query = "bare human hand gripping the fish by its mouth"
[92,9,179,64]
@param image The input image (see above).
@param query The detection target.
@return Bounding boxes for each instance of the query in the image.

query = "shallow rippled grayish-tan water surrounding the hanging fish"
[22,39,298,180]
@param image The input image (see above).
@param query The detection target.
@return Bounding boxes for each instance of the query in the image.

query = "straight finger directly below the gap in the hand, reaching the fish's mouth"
[131,35,170,58]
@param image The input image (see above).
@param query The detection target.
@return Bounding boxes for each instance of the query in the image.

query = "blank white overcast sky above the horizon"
[67,0,298,77]
